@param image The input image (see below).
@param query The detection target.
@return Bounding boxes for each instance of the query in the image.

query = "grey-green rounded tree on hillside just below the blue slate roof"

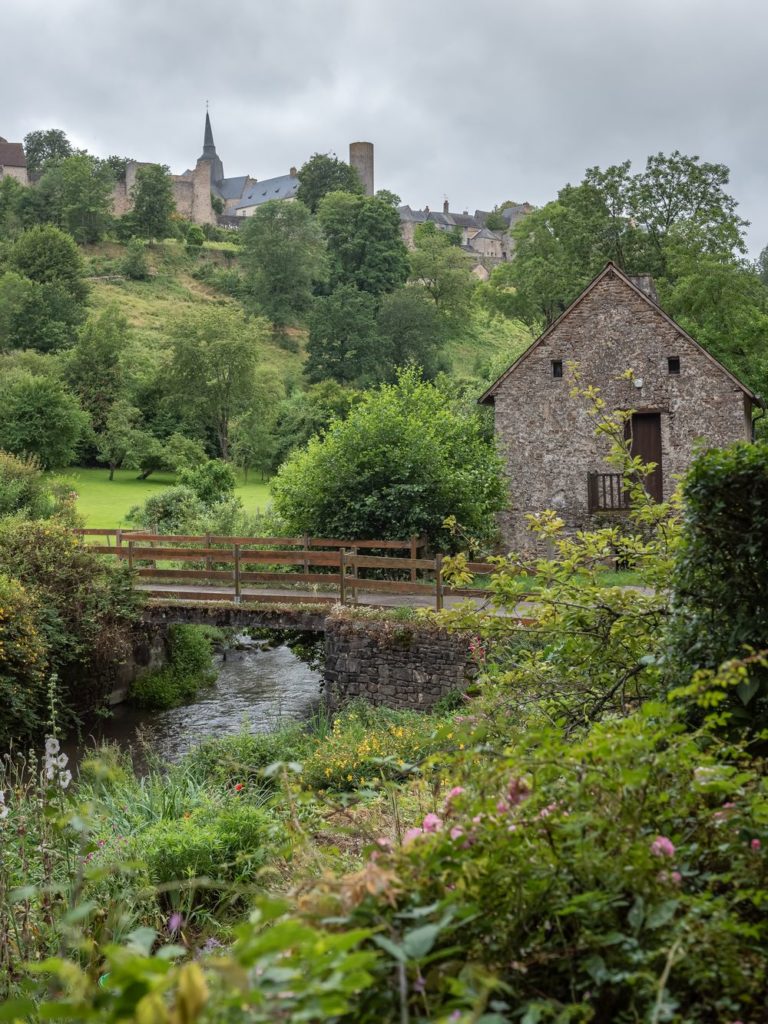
[242,201,327,328]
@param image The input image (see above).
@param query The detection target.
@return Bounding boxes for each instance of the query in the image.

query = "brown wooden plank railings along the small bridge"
[70,529,496,610]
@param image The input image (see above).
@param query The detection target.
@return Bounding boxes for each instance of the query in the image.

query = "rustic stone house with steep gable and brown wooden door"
[479,263,757,550]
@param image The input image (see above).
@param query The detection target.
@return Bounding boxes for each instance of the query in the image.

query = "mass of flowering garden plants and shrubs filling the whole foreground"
[0,428,768,1024]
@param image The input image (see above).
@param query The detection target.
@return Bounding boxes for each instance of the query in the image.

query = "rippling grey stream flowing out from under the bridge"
[80,647,323,762]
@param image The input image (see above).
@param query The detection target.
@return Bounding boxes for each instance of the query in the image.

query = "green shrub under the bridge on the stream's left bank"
[130,626,216,708]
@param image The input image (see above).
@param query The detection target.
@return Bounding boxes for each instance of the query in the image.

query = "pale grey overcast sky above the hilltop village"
[0,0,768,255]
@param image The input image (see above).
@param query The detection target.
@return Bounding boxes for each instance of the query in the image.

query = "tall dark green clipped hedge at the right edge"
[670,441,768,728]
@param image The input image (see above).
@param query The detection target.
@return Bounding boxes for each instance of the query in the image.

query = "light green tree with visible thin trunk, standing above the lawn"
[168,306,264,460]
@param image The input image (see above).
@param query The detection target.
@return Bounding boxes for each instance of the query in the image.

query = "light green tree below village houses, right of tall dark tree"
[411,221,477,333]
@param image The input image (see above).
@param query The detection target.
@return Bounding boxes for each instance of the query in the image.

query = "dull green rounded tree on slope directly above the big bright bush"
[376,287,447,379]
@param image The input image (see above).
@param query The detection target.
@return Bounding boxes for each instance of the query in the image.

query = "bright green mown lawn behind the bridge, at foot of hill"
[61,467,269,527]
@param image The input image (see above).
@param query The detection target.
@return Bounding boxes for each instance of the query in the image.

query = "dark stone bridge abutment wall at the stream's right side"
[325,616,476,711]
